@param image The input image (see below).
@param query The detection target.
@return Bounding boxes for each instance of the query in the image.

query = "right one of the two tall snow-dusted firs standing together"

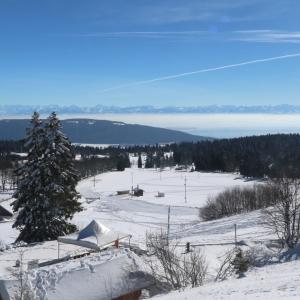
[43,112,81,234]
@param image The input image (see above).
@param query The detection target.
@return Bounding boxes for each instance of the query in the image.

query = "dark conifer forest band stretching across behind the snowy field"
[0,134,300,178]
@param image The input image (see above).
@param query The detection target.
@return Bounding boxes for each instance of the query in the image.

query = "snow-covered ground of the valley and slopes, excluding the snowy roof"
[0,167,300,300]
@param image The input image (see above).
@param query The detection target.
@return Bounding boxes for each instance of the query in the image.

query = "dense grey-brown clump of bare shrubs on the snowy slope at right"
[200,184,278,221]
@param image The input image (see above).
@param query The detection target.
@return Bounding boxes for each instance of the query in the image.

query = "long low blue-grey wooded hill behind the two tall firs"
[0,119,209,145]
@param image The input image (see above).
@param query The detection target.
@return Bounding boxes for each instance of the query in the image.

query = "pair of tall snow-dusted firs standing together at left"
[13,113,81,243]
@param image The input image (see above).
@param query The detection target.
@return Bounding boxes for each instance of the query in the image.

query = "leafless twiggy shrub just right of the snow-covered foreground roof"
[147,233,207,289]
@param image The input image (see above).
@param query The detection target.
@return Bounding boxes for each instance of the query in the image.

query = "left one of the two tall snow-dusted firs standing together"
[12,112,47,242]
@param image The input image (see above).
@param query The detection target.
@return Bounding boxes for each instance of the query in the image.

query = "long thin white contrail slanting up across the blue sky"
[99,53,300,94]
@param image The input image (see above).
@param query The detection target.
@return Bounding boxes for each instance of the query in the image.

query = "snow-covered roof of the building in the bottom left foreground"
[0,249,154,300]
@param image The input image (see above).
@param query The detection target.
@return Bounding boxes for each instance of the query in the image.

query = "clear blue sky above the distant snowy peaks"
[0,0,300,106]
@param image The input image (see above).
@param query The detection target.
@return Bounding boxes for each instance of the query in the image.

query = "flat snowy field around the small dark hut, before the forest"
[75,168,253,243]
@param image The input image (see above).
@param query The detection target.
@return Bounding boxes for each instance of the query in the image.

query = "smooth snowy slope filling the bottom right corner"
[153,261,300,300]
